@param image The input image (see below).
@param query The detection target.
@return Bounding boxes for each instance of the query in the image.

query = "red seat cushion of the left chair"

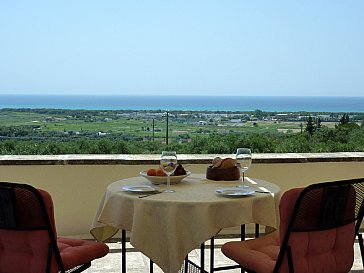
[57,237,109,270]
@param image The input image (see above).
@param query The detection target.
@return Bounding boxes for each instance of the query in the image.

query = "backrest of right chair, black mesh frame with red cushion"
[274,178,364,273]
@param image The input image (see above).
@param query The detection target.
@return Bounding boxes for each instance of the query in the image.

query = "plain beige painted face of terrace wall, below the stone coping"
[0,162,364,238]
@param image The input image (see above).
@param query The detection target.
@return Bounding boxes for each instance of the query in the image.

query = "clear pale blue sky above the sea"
[0,0,364,96]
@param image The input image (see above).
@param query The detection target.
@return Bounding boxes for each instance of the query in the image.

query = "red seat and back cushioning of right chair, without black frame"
[221,189,355,273]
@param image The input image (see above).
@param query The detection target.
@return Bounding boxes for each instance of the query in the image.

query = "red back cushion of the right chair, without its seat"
[279,188,355,273]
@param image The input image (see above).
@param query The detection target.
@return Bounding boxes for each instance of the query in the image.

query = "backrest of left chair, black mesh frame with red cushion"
[0,182,64,273]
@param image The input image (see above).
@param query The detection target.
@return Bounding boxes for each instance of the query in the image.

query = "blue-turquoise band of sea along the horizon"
[0,95,364,113]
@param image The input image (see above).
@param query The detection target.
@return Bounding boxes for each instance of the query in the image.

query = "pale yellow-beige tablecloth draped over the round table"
[90,174,280,273]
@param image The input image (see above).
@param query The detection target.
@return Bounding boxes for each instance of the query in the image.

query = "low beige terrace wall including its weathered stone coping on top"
[0,153,364,238]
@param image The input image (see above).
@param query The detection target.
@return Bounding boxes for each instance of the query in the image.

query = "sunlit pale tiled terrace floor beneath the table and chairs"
[85,235,364,273]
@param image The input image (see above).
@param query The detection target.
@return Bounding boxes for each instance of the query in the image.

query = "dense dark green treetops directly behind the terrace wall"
[0,124,364,155]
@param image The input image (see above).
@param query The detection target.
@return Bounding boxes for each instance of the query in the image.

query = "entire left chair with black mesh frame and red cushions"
[0,182,109,273]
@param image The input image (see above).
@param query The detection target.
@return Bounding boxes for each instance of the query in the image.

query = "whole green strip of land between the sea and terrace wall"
[0,109,364,155]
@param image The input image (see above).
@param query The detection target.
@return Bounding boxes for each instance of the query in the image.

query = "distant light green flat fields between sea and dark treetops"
[0,110,342,139]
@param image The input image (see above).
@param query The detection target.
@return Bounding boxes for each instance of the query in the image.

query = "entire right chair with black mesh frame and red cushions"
[221,178,364,273]
